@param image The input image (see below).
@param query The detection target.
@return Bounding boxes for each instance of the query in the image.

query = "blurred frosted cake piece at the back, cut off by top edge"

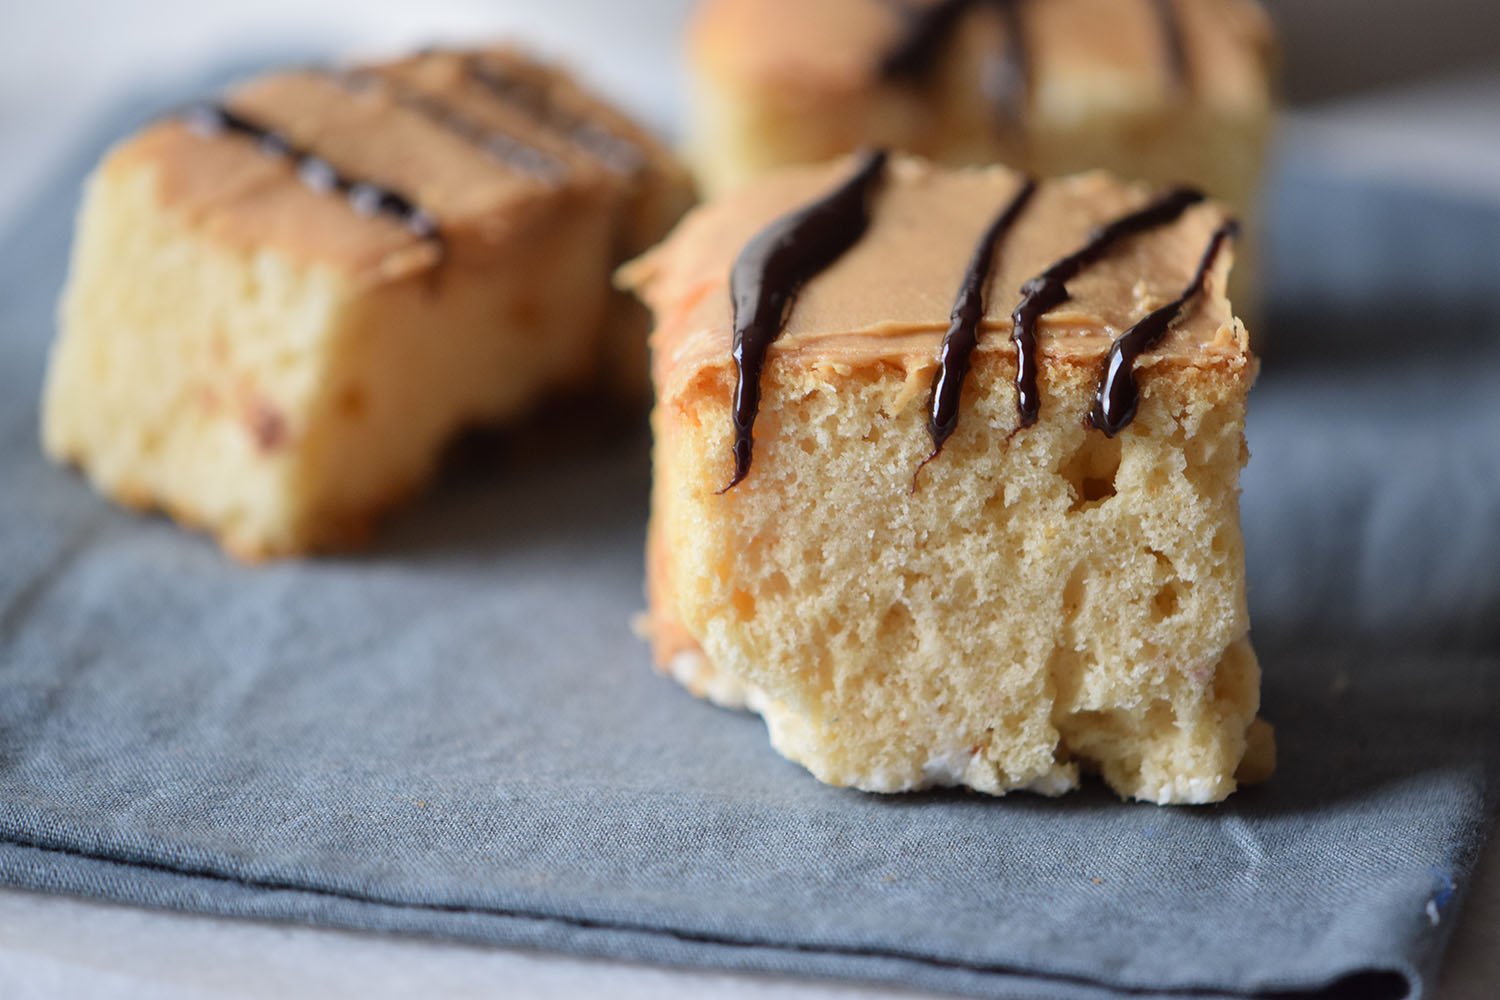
[687,0,1272,230]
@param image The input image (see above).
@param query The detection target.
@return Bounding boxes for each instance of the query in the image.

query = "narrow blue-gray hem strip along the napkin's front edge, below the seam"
[0,838,1422,1000]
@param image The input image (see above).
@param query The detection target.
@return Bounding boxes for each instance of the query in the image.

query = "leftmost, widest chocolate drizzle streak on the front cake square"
[719,150,887,493]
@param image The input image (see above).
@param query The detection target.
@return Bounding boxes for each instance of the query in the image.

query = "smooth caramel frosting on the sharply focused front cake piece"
[621,157,1247,394]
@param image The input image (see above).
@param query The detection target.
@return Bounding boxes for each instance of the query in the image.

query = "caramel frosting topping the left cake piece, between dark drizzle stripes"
[108,49,686,277]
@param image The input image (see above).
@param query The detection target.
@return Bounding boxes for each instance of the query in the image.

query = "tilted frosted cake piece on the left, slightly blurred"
[42,49,692,559]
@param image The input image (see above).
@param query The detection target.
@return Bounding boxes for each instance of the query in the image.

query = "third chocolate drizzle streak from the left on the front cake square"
[1011,187,1203,427]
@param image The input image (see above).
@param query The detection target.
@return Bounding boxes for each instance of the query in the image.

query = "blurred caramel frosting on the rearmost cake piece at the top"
[692,0,1272,114]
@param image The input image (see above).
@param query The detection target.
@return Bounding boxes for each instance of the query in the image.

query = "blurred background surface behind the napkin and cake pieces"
[0,0,1500,229]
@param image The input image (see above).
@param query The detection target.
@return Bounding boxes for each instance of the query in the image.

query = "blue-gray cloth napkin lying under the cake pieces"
[0,86,1500,997]
